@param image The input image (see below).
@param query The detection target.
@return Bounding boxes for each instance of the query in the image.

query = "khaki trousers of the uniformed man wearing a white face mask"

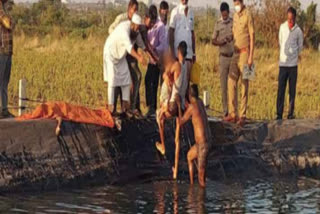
[228,52,249,118]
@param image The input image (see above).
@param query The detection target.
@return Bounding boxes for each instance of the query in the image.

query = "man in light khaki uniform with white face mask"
[225,0,254,126]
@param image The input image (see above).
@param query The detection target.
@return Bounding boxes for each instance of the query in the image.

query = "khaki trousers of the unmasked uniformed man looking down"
[219,55,232,116]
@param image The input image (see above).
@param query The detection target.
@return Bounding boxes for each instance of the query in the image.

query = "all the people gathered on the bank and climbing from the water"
[0,0,303,186]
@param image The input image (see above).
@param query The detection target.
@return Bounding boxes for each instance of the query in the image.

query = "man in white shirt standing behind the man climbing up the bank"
[169,0,196,79]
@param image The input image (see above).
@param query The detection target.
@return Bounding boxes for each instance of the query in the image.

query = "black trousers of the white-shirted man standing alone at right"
[277,66,298,119]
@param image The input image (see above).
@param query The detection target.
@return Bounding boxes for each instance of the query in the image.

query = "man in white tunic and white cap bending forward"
[103,14,144,112]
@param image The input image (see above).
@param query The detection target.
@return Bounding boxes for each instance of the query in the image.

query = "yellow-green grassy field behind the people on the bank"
[9,35,320,119]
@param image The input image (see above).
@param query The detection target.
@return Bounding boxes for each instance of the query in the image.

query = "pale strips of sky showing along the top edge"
[14,0,320,12]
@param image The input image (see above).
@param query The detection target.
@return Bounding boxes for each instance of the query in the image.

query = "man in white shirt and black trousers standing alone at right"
[277,7,303,120]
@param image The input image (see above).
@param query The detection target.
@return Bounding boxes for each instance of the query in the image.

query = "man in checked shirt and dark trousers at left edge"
[0,0,13,119]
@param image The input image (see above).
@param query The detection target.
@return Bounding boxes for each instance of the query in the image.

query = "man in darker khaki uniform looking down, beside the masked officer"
[212,2,233,117]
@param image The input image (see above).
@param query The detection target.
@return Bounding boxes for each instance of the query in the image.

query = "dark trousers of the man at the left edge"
[0,55,12,112]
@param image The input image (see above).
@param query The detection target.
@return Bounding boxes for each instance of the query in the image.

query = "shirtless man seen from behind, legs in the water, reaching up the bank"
[177,85,210,187]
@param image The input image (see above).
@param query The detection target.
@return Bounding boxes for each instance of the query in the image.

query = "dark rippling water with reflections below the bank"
[0,178,320,214]
